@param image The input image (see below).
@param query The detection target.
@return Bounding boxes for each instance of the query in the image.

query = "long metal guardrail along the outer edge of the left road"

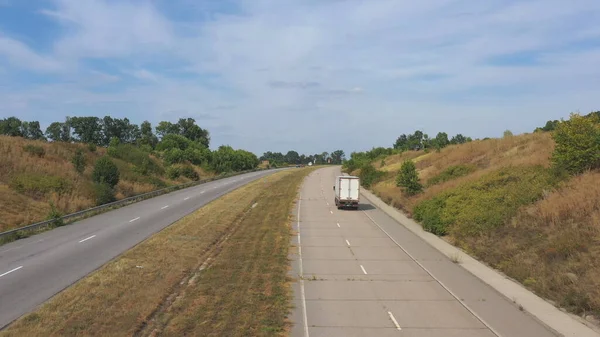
[0,169,271,245]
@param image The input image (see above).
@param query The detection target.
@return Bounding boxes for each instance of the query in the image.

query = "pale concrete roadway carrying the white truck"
[292,168,558,337]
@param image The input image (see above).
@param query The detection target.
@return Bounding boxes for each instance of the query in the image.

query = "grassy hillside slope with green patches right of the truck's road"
[350,125,600,322]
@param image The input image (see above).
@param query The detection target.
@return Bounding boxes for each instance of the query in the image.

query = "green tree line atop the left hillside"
[0,116,259,176]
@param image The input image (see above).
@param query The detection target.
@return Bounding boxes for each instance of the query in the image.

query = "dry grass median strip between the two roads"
[0,169,311,336]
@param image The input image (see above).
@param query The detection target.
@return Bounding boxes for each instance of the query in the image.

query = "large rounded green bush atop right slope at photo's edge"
[552,114,600,174]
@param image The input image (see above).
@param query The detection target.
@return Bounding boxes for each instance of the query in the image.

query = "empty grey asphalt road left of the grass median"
[0,170,282,328]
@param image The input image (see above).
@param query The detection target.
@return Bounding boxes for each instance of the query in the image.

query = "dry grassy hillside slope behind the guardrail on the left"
[0,136,214,231]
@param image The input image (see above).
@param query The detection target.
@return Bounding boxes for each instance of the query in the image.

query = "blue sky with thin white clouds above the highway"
[0,0,600,155]
